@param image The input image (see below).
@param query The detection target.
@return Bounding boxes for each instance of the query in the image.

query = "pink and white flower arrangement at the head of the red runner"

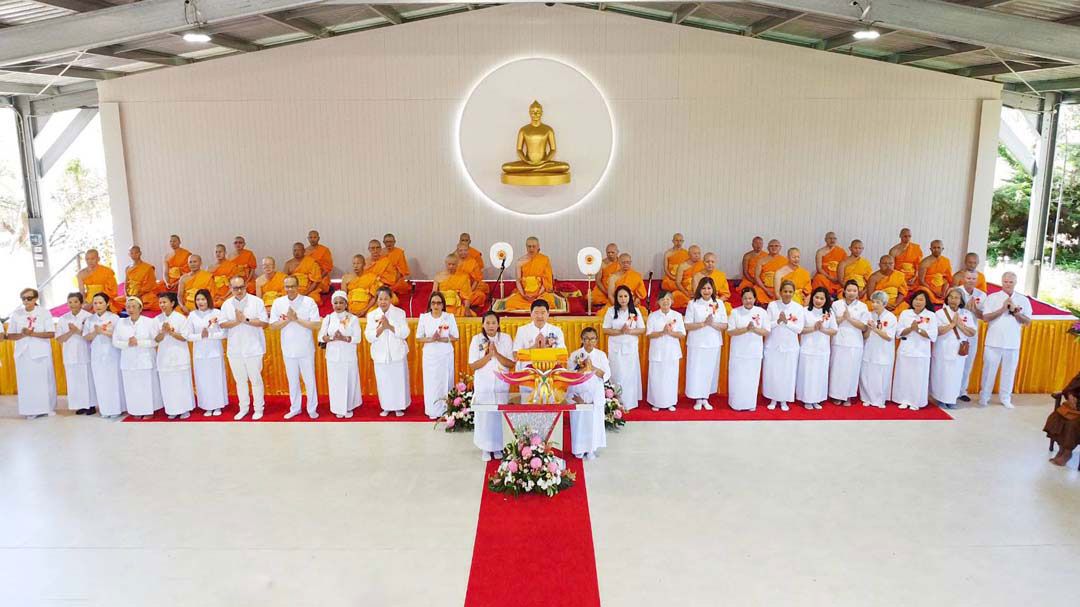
[487,432,577,497]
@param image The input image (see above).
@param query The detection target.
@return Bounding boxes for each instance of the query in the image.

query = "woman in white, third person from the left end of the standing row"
[82,293,126,418]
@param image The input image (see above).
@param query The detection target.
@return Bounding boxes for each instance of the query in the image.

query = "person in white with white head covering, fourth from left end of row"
[112,297,164,419]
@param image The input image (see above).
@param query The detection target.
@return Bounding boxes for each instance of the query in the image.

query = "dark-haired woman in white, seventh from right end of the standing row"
[795,286,837,410]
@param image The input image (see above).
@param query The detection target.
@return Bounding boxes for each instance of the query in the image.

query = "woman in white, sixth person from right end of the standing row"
[828,280,870,407]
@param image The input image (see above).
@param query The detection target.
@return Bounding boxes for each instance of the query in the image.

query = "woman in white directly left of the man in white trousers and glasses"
[187,288,229,417]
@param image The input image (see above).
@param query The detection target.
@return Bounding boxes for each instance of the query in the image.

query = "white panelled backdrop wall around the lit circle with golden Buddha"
[99,4,999,278]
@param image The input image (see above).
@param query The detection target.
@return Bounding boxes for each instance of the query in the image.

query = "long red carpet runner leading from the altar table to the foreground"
[465,410,600,607]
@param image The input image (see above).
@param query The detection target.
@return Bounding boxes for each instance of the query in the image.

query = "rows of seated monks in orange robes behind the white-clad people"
[71,228,986,316]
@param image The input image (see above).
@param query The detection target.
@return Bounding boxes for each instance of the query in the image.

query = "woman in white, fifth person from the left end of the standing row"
[153,293,195,419]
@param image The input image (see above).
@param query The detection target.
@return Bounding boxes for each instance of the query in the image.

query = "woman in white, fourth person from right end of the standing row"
[892,291,937,410]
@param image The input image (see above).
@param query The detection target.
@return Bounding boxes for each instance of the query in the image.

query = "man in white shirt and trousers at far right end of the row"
[978,272,1031,409]
